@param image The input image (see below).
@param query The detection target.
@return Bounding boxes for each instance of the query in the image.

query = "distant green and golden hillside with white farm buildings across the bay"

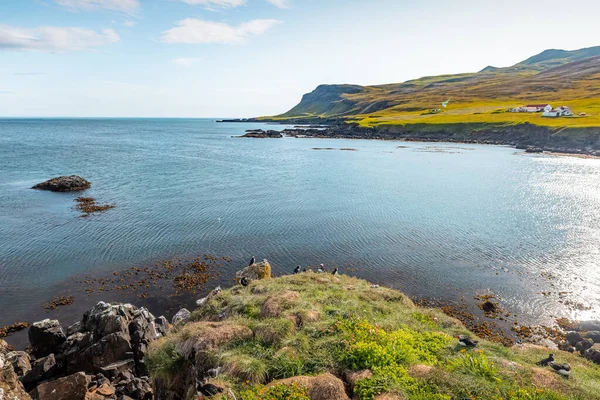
[266,47,600,128]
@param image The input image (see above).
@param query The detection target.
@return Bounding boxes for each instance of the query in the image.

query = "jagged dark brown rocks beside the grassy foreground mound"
[15,302,170,400]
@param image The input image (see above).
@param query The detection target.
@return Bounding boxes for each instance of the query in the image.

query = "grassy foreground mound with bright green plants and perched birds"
[148,273,600,400]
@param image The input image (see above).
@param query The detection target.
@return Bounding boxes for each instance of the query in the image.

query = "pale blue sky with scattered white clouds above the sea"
[0,0,600,118]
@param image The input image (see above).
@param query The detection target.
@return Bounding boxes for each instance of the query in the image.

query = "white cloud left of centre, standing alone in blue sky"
[161,18,281,44]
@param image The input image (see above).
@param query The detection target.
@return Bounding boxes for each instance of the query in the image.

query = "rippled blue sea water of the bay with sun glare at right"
[0,119,600,346]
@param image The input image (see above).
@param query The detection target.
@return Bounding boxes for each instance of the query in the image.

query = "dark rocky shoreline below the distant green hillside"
[223,119,600,157]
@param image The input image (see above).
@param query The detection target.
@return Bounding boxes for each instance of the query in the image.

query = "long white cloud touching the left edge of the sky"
[0,25,119,52]
